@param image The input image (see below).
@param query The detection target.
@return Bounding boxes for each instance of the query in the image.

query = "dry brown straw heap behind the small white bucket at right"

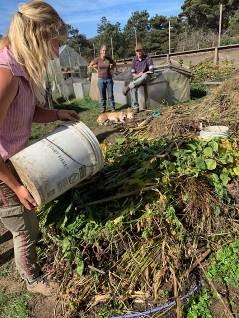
[148,75,239,138]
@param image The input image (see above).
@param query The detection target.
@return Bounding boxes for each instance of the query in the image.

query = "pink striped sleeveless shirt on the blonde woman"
[0,48,35,161]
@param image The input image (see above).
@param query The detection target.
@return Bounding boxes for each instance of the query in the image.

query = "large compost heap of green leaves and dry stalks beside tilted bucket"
[38,76,239,317]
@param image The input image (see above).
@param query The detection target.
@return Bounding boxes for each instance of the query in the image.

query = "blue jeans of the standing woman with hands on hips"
[98,78,115,110]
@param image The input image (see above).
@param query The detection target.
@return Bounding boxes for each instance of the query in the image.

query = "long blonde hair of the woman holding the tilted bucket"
[0,0,67,104]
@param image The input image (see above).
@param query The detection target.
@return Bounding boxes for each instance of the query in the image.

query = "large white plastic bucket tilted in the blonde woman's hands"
[10,122,104,206]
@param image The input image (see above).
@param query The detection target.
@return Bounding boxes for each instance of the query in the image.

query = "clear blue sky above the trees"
[0,0,184,38]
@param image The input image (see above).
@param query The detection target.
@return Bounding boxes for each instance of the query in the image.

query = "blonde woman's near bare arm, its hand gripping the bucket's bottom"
[0,67,36,210]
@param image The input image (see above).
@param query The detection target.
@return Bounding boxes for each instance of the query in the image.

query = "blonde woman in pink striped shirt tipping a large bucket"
[0,1,79,296]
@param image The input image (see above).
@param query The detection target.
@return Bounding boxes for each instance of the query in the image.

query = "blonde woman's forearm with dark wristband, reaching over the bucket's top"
[33,106,80,123]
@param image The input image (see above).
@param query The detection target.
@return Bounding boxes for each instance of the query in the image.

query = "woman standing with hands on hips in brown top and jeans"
[89,45,116,113]
